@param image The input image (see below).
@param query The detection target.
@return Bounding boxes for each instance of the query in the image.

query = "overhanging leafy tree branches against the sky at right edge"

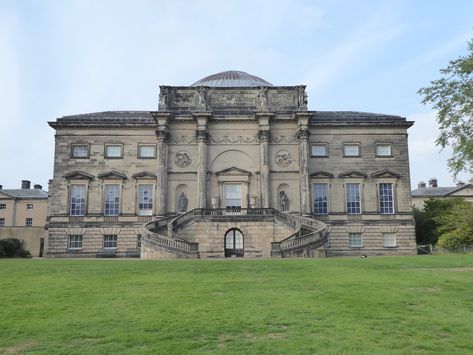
[418,40,473,177]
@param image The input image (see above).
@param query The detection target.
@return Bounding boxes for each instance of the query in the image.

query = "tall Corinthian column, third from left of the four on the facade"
[257,113,272,208]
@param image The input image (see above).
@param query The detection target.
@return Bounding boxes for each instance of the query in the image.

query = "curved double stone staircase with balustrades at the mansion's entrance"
[142,208,328,259]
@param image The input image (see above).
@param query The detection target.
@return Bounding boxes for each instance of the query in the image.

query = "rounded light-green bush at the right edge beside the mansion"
[435,200,473,249]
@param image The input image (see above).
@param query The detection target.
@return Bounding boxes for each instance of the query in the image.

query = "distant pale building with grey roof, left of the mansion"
[0,180,48,256]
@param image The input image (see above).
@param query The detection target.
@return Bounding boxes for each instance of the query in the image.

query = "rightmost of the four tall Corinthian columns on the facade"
[296,114,311,215]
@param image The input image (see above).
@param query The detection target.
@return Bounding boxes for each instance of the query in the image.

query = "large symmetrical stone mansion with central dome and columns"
[46,71,416,258]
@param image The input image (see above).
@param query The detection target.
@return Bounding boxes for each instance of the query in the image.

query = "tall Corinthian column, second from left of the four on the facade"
[194,113,209,208]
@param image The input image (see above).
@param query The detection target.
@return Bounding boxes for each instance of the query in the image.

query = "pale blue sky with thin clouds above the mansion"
[0,0,473,188]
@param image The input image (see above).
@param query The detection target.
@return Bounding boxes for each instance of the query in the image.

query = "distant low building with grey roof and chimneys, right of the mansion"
[411,178,473,210]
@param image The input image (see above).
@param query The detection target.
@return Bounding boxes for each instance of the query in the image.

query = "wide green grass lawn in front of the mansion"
[0,255,473,354]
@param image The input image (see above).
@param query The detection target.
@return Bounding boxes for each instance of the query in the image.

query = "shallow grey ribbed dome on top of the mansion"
[191,70,273,87]
